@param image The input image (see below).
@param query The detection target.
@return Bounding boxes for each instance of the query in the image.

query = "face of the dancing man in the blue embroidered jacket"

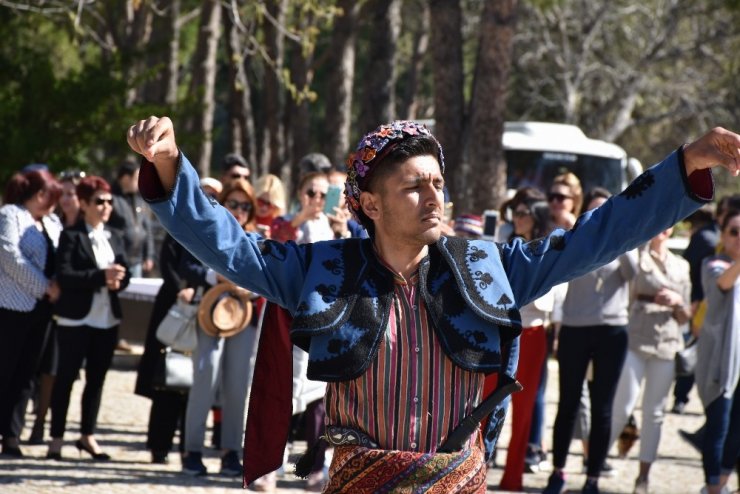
[371,156,444,246]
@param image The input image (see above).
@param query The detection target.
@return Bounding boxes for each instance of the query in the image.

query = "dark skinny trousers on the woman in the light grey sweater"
[553,326,627,477]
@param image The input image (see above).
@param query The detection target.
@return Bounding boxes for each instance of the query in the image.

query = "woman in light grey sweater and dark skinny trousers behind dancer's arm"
[543,187,637,494]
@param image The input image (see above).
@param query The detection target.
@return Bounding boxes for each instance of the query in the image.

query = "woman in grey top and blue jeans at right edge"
[694,209,740,494]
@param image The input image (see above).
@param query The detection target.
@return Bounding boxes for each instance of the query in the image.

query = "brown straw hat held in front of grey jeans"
[198,283,252,338]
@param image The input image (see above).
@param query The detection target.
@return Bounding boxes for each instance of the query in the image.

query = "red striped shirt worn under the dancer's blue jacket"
[326,266,484,452]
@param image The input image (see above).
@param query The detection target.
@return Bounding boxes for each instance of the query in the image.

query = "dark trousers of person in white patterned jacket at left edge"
[0,301,51,438]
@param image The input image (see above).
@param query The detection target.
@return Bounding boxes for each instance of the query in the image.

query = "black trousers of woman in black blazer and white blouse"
[51,326,118,438]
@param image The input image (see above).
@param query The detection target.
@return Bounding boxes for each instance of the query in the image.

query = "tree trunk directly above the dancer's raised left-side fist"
[142,0,180,105]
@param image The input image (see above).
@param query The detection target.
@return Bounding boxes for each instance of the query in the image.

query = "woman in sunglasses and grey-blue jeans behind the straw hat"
[177,179,259,476]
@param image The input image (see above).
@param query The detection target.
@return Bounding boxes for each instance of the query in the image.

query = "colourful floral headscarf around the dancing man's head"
[344,120,445,220]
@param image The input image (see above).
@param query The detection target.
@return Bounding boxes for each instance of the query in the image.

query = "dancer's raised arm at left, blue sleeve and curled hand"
[127,117,307,312]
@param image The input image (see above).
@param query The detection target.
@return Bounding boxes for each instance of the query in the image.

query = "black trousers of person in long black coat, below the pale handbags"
[146,391,188,453]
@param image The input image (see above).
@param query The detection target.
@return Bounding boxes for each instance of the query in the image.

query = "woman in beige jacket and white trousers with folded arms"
[610,228,691,494]
